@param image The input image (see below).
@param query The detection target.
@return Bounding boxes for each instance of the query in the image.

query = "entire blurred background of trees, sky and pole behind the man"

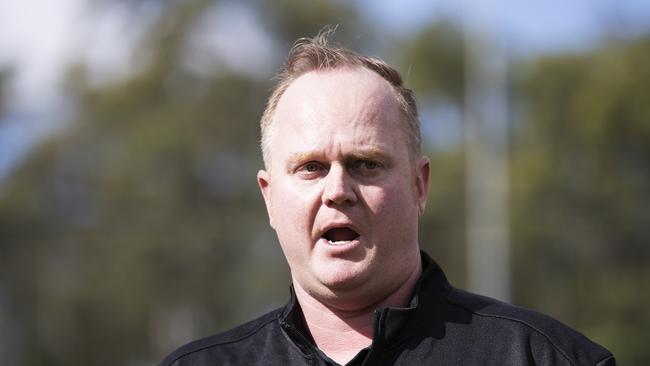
[0,0,650,366]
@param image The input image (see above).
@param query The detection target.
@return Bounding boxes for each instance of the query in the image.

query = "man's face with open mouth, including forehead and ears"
[258,68,429,309]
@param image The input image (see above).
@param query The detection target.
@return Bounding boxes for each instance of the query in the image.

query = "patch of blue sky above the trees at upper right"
[359,0,650,53]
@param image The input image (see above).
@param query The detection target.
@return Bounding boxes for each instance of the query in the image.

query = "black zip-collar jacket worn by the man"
[162,253,616,366]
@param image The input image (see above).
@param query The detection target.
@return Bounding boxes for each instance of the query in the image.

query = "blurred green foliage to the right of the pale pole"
[512,35,650,365]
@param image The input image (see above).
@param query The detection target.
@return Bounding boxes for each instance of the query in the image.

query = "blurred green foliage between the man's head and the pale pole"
[394,22,466,286]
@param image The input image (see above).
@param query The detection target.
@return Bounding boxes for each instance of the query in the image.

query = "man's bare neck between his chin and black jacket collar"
[294,266,422,364]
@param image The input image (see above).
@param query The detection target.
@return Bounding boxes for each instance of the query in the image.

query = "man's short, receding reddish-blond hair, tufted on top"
[260,27,422,168]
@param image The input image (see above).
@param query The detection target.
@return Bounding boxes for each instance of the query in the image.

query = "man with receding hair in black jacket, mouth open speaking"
[163,32,615,366]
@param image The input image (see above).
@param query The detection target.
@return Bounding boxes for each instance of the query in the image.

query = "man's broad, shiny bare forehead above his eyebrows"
[272,68,404,150]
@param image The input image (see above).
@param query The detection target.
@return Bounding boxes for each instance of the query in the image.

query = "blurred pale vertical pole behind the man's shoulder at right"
[464,0,510,301]
